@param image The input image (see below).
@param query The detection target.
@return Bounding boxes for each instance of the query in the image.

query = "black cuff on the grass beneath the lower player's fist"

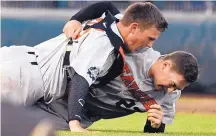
[143,120,165,133]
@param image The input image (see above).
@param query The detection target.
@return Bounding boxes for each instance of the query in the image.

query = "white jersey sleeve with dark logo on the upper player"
[70,31,114,86]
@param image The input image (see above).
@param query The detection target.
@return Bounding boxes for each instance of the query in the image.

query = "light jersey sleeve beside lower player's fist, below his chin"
[161,90,181,124]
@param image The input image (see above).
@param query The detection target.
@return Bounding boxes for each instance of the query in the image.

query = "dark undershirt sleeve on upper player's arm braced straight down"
[67,72,89,122]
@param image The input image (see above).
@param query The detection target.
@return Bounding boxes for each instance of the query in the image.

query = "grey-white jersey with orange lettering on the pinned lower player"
[90,48,181,124]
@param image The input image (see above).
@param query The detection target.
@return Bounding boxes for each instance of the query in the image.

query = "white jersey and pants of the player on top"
[1,15,120,105]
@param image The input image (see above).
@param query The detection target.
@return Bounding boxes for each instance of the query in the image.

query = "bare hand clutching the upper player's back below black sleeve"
[63,20,82,39]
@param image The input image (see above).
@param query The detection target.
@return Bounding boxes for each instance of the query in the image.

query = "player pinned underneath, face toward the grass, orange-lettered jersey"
[34,48,198,133]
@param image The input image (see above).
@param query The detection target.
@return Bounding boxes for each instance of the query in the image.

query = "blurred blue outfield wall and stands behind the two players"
[1,1,216,94]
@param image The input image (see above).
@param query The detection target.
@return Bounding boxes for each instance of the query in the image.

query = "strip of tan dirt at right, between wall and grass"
[176,94,216,114]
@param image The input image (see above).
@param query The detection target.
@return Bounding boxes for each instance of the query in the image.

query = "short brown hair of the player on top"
[121,2,168,32]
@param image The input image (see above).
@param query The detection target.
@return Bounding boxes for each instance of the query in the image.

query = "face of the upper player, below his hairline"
[127,24,161,52]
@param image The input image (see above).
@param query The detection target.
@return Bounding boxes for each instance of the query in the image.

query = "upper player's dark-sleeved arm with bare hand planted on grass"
[67,67,89,132]
